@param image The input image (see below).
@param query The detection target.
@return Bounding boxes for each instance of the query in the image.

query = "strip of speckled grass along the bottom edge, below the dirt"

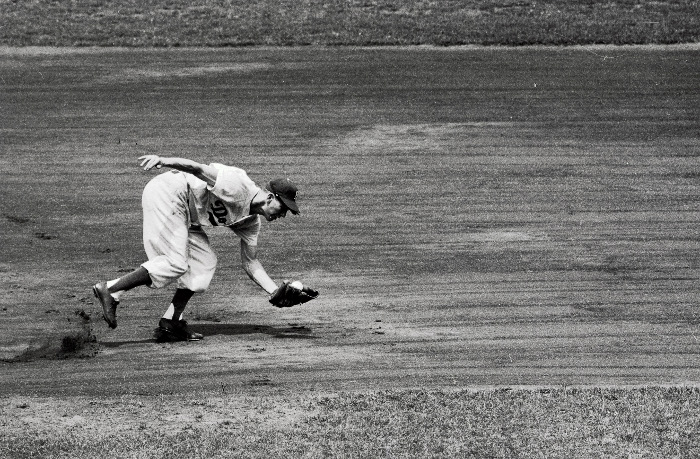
[0,387,700,458]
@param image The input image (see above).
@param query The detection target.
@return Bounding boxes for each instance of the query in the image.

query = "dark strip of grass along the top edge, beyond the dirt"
[0,0,700,46]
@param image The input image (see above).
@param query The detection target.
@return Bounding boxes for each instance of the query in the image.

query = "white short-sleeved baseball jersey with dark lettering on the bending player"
[185,163,260,245]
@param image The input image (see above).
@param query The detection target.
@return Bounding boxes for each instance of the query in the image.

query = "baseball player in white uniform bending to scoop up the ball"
[93,155,317,341]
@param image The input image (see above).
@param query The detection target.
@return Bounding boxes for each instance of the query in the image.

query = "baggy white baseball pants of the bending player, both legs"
[141,172,217,292]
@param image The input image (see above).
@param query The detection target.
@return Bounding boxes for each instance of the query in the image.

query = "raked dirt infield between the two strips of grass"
[0,48,700,396]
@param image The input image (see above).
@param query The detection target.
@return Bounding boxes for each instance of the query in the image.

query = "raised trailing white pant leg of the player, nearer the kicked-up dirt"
[141,173,189,288]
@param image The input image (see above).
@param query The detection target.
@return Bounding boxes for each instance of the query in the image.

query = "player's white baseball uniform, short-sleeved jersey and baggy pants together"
[141,163,260,292]
